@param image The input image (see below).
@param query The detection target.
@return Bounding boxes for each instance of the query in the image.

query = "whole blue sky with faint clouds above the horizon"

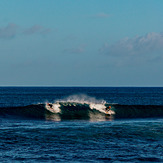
[0,0,163,86]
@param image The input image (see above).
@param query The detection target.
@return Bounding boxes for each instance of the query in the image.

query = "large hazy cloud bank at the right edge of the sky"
[99,32,163,66]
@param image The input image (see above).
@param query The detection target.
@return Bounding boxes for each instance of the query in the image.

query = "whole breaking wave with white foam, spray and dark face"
[0,95,163,121]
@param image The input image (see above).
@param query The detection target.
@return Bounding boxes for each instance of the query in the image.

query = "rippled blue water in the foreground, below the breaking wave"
[0,119,163,162]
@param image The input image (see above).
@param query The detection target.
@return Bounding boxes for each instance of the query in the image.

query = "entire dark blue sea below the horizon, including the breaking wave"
[0,87,163,162]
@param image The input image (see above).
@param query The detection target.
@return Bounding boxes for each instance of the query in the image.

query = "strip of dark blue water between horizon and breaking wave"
[0,87,163,107]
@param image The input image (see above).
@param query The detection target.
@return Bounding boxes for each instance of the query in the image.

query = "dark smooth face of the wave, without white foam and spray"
[0,102,163,121]
